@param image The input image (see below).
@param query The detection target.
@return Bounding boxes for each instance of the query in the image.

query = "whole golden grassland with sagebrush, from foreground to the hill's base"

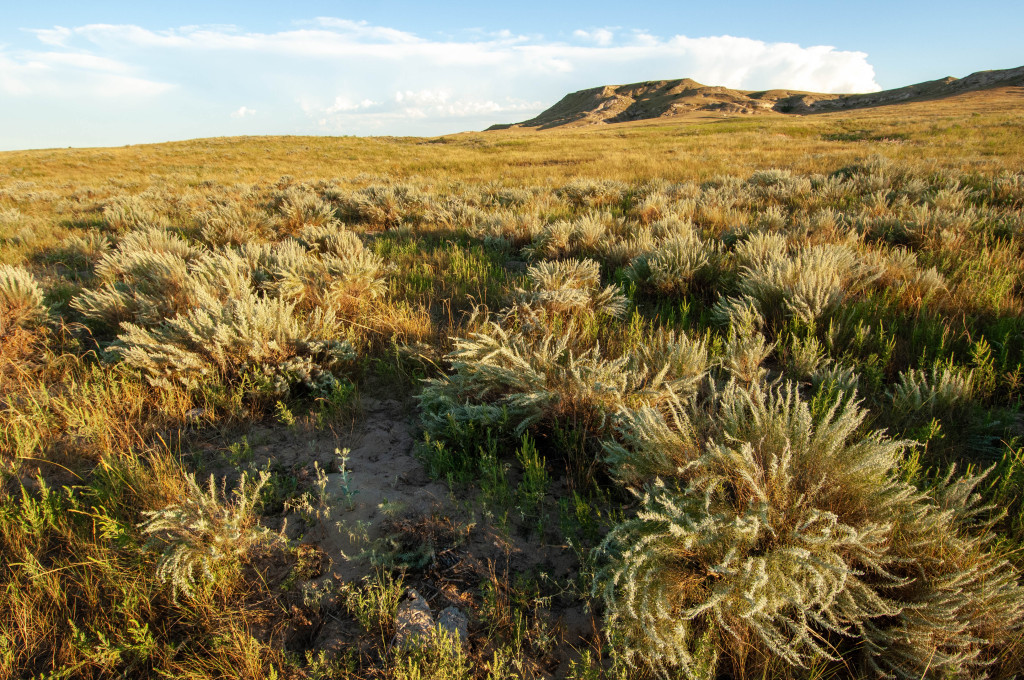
[0,88,1024,679]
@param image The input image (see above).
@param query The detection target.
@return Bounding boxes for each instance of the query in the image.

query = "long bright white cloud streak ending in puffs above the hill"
[19,17,878,91]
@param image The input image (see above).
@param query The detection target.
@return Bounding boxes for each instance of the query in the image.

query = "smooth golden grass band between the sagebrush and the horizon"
[0,88,1024,200]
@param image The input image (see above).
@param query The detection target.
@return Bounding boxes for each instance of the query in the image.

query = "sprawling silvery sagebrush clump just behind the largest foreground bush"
[419,303,709,449]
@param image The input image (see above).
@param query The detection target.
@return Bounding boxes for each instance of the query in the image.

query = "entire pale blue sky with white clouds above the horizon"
[0,0,1024,150]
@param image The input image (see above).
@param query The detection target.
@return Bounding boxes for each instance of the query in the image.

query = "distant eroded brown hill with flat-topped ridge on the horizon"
[487,67,1024,130]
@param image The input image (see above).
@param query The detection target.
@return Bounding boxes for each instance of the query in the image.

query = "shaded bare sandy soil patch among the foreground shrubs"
[207,388,600,677]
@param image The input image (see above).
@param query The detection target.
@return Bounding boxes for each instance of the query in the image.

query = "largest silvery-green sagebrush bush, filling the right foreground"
[595,383,1024,678]
